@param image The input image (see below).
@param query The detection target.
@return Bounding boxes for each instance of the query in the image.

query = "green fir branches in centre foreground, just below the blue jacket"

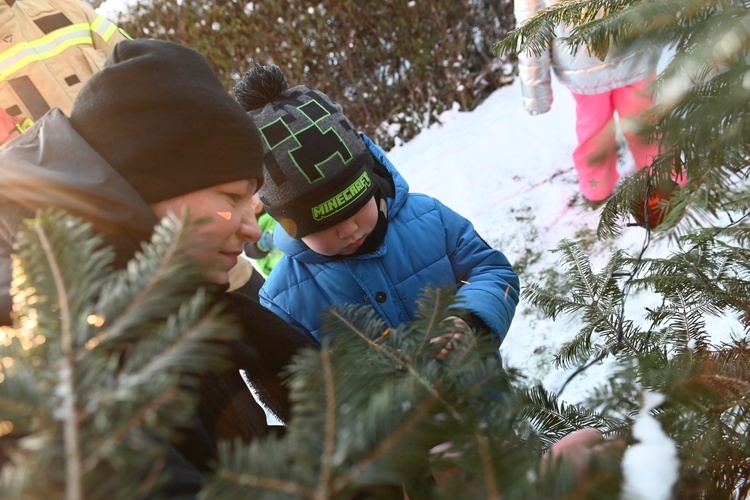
[207,289,540,498]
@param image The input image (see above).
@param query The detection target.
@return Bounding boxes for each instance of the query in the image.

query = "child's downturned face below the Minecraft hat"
[302,196,378,257]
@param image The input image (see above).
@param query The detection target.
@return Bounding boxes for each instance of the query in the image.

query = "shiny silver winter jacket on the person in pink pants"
[514,0,662,114]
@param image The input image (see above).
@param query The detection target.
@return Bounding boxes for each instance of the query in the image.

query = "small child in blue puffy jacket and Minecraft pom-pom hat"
[234,65,519,350]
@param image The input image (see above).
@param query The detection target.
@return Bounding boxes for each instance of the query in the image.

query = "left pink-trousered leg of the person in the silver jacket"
[573,92,619,201]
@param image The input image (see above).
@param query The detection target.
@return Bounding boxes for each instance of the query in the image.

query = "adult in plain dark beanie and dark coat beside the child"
[0,40,317,498]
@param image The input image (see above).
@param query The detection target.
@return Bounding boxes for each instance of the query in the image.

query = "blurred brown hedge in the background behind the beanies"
[113,0,514,149]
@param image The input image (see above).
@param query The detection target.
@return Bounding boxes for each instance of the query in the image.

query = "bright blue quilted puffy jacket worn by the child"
[260,136,519,342]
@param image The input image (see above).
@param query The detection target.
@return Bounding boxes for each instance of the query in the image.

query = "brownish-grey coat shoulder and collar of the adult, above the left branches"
[0,109,157,325]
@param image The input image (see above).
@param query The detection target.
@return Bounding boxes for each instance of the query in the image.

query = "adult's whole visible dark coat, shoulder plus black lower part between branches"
[0,109,316,495]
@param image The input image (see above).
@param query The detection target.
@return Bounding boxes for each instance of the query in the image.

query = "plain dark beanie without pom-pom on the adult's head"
[70,39,263,204]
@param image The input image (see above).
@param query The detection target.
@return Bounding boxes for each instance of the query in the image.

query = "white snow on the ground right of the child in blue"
[388,74,741,403]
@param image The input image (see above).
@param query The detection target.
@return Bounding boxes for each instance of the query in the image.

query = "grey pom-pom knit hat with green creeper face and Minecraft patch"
[234,65,375,238]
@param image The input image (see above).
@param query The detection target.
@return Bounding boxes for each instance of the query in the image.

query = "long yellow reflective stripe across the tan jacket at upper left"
[0,23,94,81]
